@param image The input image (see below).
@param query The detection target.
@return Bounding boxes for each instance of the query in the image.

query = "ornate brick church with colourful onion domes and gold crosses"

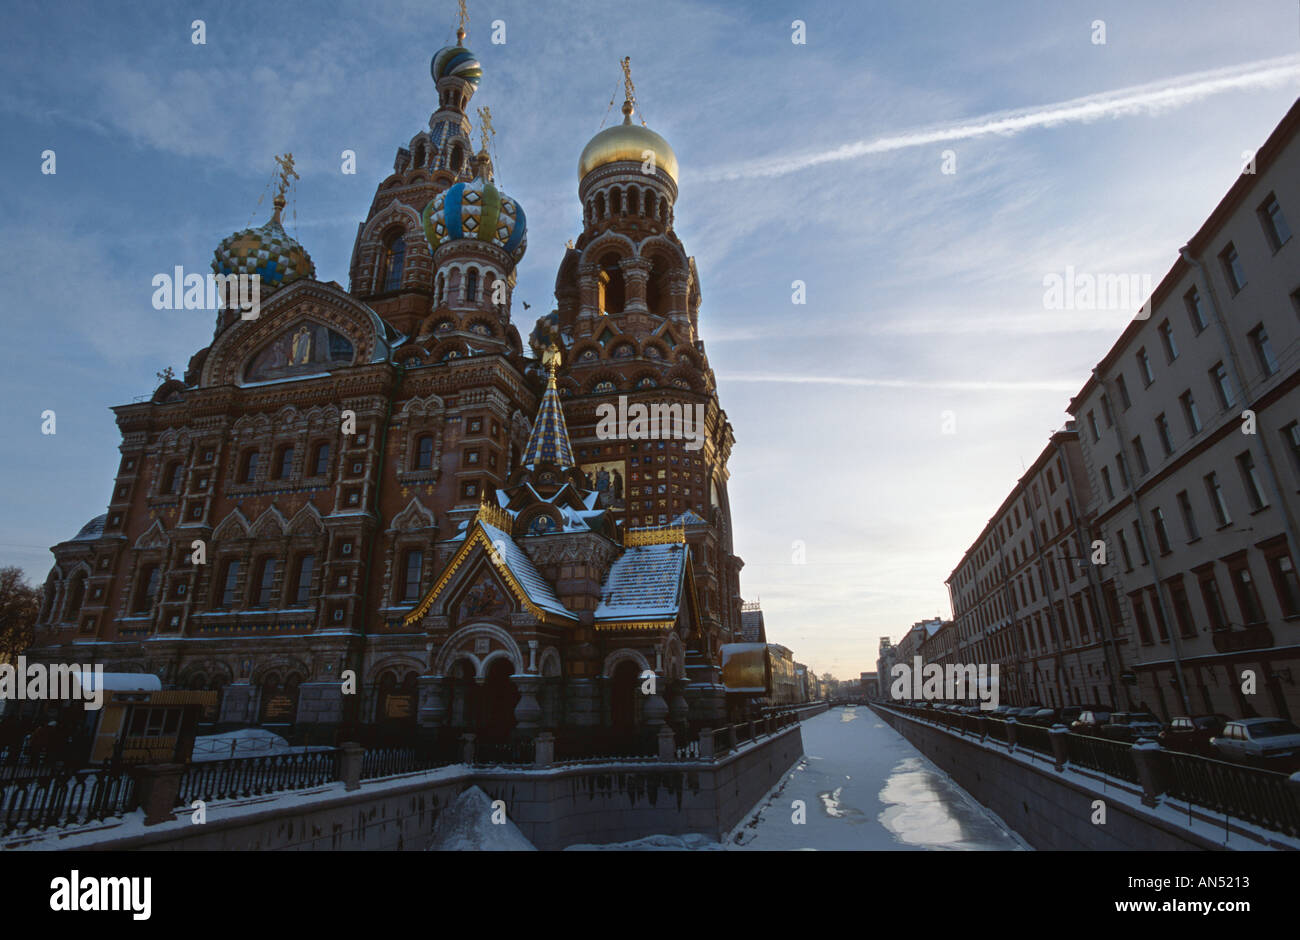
[27,16,742,742]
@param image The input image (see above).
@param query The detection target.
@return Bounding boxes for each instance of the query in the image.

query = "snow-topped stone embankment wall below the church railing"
[22,724,803,850]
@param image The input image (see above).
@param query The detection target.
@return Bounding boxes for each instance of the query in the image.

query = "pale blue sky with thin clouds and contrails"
[0,0,1300,677]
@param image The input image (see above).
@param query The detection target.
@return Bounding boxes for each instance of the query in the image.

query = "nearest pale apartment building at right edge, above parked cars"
[1067,103,1300,720]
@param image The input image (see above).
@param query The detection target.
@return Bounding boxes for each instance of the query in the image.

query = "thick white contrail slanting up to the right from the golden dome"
[699,56,1300,181]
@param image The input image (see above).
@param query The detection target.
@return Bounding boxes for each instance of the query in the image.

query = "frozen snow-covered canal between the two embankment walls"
[727,706,1027,850]
